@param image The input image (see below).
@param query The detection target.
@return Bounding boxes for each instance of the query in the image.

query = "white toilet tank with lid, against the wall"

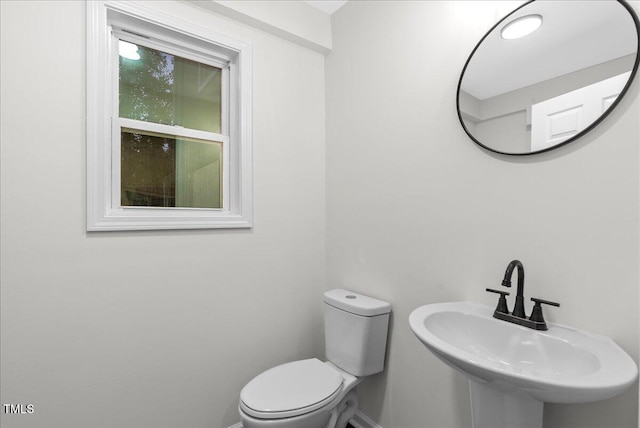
[324,289,391,376]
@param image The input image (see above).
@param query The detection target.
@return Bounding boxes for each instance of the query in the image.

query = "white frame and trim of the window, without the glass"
[86,1,253,231]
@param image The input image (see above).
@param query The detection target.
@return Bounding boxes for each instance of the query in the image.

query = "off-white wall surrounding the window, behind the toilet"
[0,1,325,428]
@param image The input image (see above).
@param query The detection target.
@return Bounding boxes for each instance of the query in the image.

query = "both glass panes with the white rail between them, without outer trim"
[118,39,229,209]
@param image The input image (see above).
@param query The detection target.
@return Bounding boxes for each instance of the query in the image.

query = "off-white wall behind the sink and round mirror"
[326,1,640,428]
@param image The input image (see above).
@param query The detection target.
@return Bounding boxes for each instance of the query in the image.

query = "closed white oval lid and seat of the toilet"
[240,358,344,419]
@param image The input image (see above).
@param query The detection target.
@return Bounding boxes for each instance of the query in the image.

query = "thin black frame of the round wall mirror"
[456,0,640,156]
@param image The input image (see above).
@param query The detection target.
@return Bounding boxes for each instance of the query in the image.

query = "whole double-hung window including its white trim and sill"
[87,1,252,231]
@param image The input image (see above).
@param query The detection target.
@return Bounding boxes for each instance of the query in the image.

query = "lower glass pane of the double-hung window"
[120,129,222,208]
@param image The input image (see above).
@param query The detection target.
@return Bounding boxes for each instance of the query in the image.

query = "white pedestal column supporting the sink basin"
[469,380,544,428]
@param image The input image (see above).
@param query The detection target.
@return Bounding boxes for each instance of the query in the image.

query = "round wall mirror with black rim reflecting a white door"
[457,0,640,155]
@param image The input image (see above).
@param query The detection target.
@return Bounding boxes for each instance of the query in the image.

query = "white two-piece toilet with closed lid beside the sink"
[238,289,391,428]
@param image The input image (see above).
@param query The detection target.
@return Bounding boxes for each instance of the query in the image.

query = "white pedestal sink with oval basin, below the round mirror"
[409,302,638,428]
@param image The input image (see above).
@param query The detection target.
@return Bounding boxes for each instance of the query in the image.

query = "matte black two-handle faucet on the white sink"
[487,260,560,330]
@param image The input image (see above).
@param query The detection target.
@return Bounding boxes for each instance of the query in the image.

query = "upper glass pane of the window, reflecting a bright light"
[119,40,222,134]
